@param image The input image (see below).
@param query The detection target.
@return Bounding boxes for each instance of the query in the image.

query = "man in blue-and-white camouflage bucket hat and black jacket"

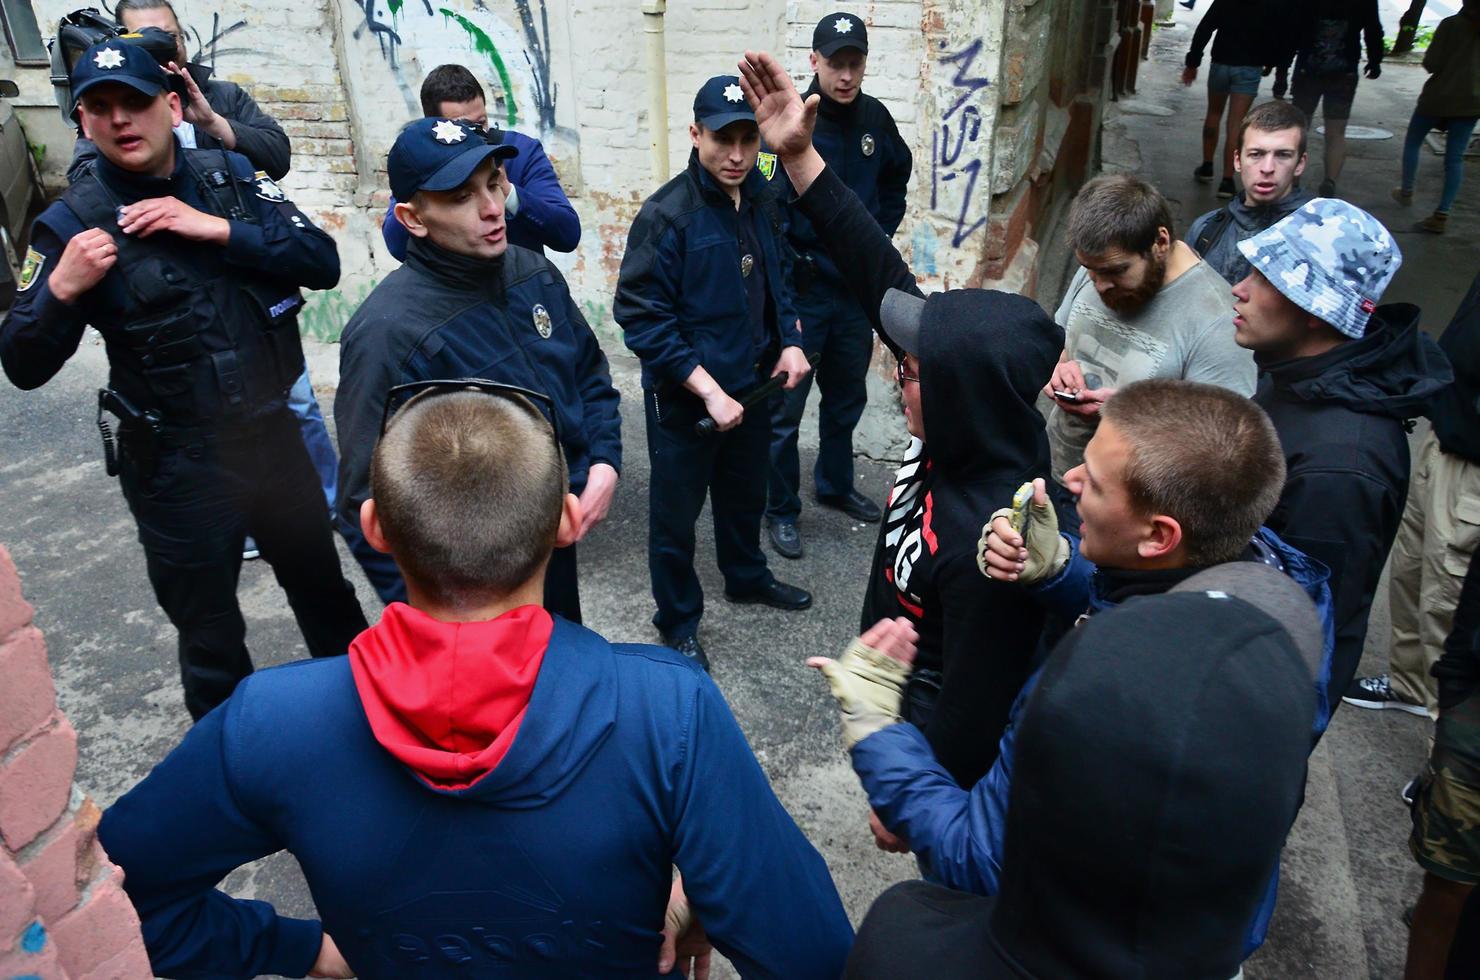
[1233,197,1452,705]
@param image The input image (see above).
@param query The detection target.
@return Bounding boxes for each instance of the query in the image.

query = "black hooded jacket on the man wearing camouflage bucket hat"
[1254,303,1453,706]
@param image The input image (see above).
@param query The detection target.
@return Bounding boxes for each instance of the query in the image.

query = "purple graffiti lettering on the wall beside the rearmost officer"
[929,38,992,249]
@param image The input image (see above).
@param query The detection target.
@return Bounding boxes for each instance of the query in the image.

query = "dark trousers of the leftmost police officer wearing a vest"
[118,407,366,719]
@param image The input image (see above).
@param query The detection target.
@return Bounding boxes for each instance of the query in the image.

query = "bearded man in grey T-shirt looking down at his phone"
[1043,173,1255,518]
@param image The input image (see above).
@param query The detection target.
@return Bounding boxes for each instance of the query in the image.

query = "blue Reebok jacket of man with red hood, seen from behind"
[98,619,852,980]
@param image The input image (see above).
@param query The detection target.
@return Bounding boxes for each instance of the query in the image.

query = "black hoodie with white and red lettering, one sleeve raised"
[796,167,1064,788]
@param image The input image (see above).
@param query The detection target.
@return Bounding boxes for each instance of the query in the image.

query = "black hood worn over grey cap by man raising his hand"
[918,289,1064,482]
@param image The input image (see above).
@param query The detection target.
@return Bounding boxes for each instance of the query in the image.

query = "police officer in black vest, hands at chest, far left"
[0,38,366,718]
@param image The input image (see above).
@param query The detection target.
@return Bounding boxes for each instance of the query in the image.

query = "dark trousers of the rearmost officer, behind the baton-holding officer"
[765,286,873,521]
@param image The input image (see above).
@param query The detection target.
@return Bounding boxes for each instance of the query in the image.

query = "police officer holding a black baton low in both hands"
[613,75,813,669]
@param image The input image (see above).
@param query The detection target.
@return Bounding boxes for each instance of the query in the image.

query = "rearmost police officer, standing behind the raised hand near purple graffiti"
[765,13,910,558]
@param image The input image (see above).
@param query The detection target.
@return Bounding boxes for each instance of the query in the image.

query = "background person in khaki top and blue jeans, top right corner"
[1393,0,1480,235]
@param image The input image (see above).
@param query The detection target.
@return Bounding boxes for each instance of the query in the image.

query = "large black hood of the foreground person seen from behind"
[989,591,1316,980]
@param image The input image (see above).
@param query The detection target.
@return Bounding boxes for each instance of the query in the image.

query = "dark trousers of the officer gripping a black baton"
[642,378,774,640]
